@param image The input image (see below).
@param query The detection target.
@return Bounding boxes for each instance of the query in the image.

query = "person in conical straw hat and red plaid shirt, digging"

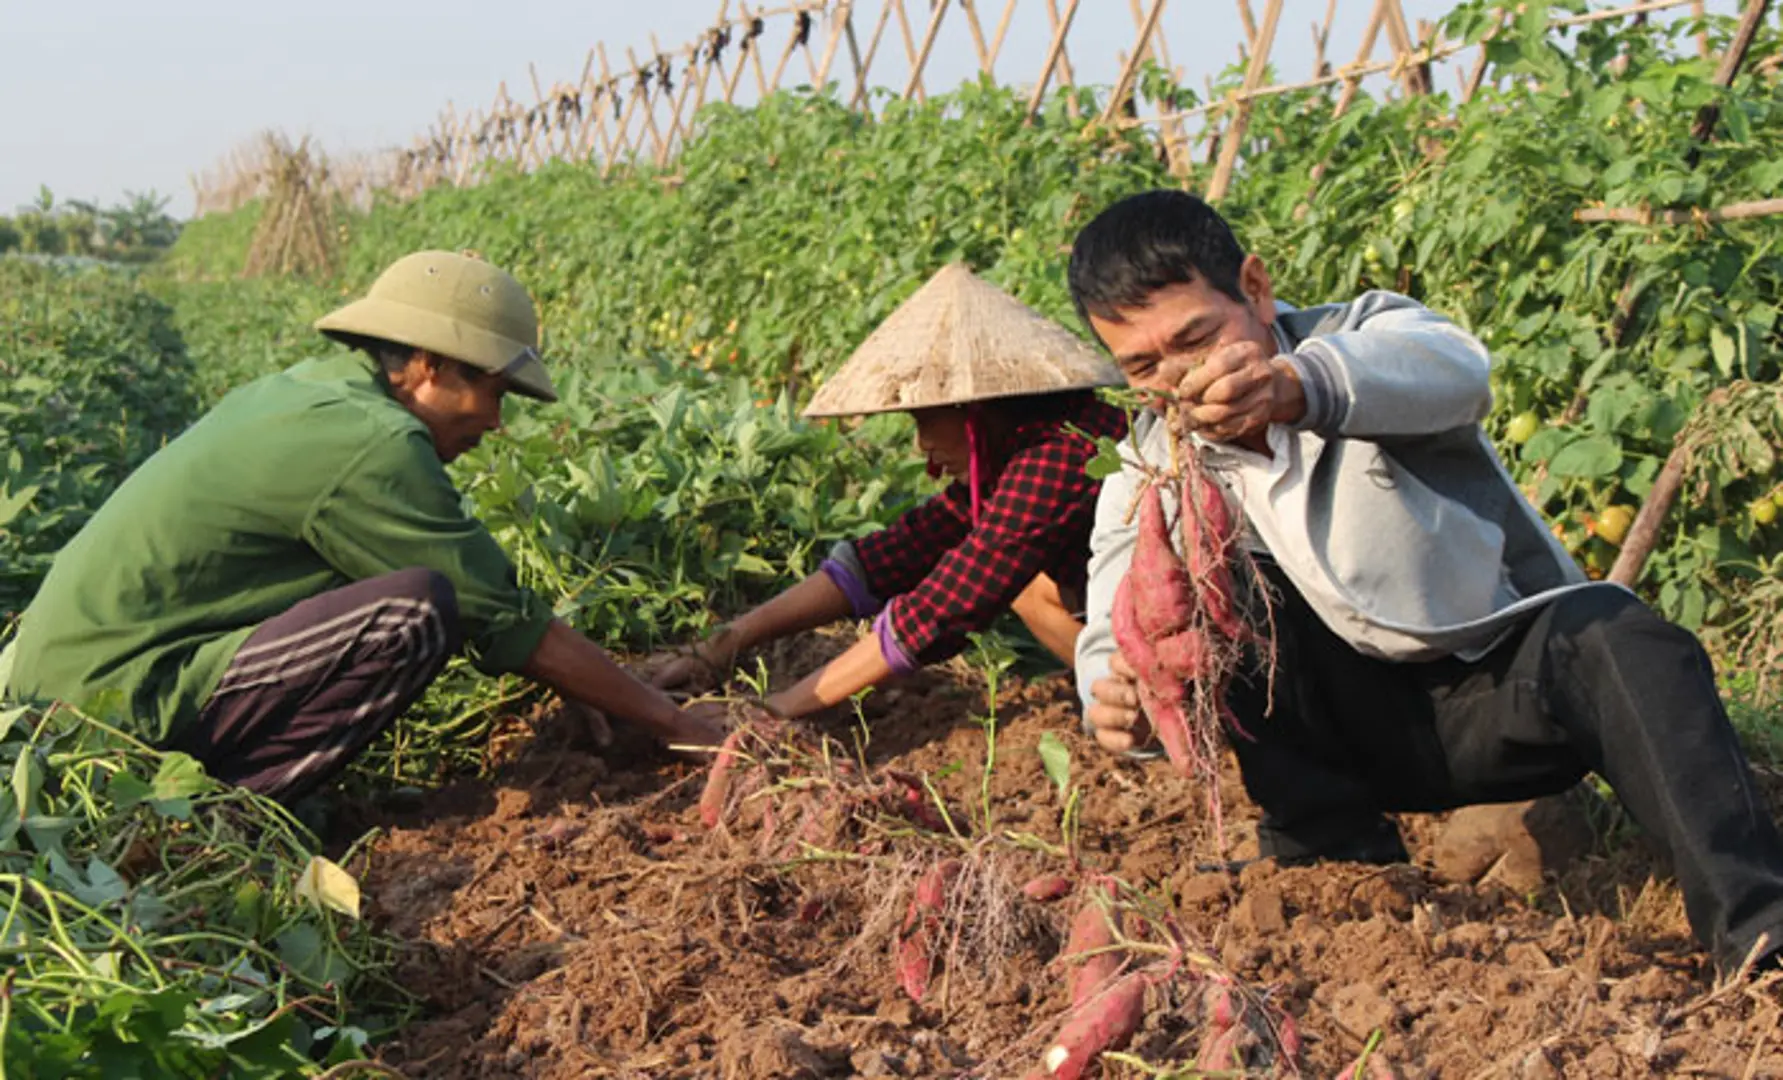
[656,264,1127,716]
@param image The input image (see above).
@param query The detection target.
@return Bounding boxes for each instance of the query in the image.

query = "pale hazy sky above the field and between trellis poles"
[0,0,1735,217]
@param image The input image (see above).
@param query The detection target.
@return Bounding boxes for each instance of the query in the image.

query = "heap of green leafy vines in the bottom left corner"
[0,709,396,1078]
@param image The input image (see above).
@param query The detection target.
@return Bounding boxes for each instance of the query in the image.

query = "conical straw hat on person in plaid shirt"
[804,262,1125,417]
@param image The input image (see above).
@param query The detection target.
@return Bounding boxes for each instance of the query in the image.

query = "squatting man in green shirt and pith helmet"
[0,251,722,802]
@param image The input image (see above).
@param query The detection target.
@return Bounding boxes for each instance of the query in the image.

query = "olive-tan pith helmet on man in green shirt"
[316,251,556,401]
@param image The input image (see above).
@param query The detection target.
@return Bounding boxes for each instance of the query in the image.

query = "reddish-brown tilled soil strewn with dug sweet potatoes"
[340,634,1783,1080]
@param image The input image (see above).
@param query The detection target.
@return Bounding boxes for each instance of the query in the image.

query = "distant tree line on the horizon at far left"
[0,187,180,262]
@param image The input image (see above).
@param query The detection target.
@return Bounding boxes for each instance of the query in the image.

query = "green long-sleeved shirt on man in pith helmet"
[7,353,551,743]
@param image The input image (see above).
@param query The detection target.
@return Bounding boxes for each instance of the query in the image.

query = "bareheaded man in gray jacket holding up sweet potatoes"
[1070,191,1783,970]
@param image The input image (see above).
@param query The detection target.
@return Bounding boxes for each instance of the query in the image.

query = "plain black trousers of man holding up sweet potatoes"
[1228,563,1783,968]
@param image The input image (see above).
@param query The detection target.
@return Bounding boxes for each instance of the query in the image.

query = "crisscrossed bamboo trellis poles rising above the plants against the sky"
[191,0,1740,214]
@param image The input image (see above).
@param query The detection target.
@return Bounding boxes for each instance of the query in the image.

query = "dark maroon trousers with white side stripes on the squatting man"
[173,570,460,804]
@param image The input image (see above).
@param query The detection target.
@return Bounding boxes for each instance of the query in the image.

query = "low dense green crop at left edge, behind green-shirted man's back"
[0,260,198,618]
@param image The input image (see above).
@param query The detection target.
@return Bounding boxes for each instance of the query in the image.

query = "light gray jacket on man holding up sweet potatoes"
[1077,292,1619,708]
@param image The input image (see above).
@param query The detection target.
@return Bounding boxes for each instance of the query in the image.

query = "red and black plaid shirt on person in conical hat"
[854,390,1127,665]
